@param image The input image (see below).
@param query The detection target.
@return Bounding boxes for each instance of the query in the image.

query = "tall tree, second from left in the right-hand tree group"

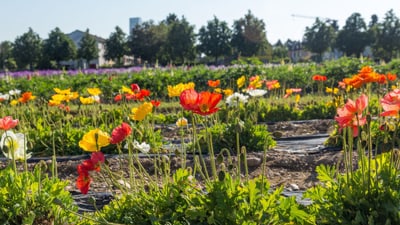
[336,13,371,56]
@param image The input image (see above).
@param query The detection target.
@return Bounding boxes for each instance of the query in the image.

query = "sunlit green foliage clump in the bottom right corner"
[304,153,400,224]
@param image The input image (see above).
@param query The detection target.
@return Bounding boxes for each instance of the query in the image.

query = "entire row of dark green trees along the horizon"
[0,10,400,70]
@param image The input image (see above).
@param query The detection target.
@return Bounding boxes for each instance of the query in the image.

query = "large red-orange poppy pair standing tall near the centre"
[180,89,222,116]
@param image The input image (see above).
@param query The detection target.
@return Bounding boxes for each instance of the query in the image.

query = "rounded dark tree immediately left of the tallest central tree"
[198,16,232,63]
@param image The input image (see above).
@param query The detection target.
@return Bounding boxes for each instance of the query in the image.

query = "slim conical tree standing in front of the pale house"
[78,29,99,65]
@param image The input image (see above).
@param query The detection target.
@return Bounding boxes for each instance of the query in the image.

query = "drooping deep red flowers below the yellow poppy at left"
[76,152,105,194]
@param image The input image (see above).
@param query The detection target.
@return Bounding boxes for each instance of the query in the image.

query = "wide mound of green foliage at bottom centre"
[83,169,314,224]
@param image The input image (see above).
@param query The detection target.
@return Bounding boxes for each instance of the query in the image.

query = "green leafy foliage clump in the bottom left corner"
[0,162,78,225]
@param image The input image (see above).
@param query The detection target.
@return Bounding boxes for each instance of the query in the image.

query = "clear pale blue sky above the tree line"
[0,0,400,44]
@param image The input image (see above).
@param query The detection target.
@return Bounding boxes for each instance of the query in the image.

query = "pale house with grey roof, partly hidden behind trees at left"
[61,30,109,69]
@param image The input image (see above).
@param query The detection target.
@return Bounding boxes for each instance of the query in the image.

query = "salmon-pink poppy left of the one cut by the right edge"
[335,94,368,137]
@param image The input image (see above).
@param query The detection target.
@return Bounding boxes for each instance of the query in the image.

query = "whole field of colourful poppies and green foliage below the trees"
[0,59,400,224]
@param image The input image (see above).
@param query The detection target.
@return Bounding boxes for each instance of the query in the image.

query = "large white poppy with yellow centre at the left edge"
[0,130,32,160]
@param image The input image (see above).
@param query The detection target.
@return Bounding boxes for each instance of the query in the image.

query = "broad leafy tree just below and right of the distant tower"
[128,21,168,63]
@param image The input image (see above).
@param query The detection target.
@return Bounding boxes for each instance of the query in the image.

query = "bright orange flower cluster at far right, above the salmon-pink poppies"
[343,66,397,88]
